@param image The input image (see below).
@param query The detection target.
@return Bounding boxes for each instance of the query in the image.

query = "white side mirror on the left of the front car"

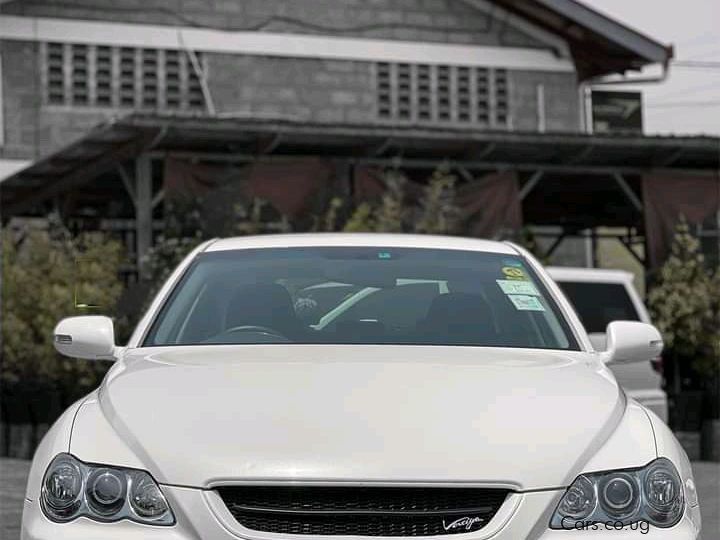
[53,315,115,360]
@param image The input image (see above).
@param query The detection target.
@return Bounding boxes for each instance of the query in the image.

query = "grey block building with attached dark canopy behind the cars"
[0,0,720,276]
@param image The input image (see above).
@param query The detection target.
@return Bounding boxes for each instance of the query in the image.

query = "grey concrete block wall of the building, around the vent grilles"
[0,0,579,159]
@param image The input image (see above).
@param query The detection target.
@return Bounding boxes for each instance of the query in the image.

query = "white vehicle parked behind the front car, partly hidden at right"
[547,267,668,422]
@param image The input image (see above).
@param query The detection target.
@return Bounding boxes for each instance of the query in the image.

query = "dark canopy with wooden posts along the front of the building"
[1,114,720,274]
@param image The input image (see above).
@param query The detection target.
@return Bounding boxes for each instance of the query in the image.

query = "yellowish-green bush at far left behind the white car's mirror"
[0,229,123,399]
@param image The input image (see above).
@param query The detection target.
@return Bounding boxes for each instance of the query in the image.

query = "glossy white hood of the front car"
[84,345,625,489]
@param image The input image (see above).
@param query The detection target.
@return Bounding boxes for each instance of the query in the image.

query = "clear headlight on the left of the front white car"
[40,454,175,525]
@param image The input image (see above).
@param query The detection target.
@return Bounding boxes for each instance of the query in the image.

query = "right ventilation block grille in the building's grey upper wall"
[375,62,510,129]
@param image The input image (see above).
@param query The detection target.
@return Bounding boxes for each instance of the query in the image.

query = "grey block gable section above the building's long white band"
[2,0,539,47]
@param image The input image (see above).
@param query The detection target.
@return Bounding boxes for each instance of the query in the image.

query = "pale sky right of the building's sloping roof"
[581,0,720,135]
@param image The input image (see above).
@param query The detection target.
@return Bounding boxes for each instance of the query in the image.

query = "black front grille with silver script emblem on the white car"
[217,486,509,536]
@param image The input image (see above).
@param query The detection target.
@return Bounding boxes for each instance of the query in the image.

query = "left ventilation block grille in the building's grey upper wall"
[41,43,205,110]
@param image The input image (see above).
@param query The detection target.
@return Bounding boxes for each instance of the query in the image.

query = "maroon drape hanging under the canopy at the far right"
[642,173,720,267]
